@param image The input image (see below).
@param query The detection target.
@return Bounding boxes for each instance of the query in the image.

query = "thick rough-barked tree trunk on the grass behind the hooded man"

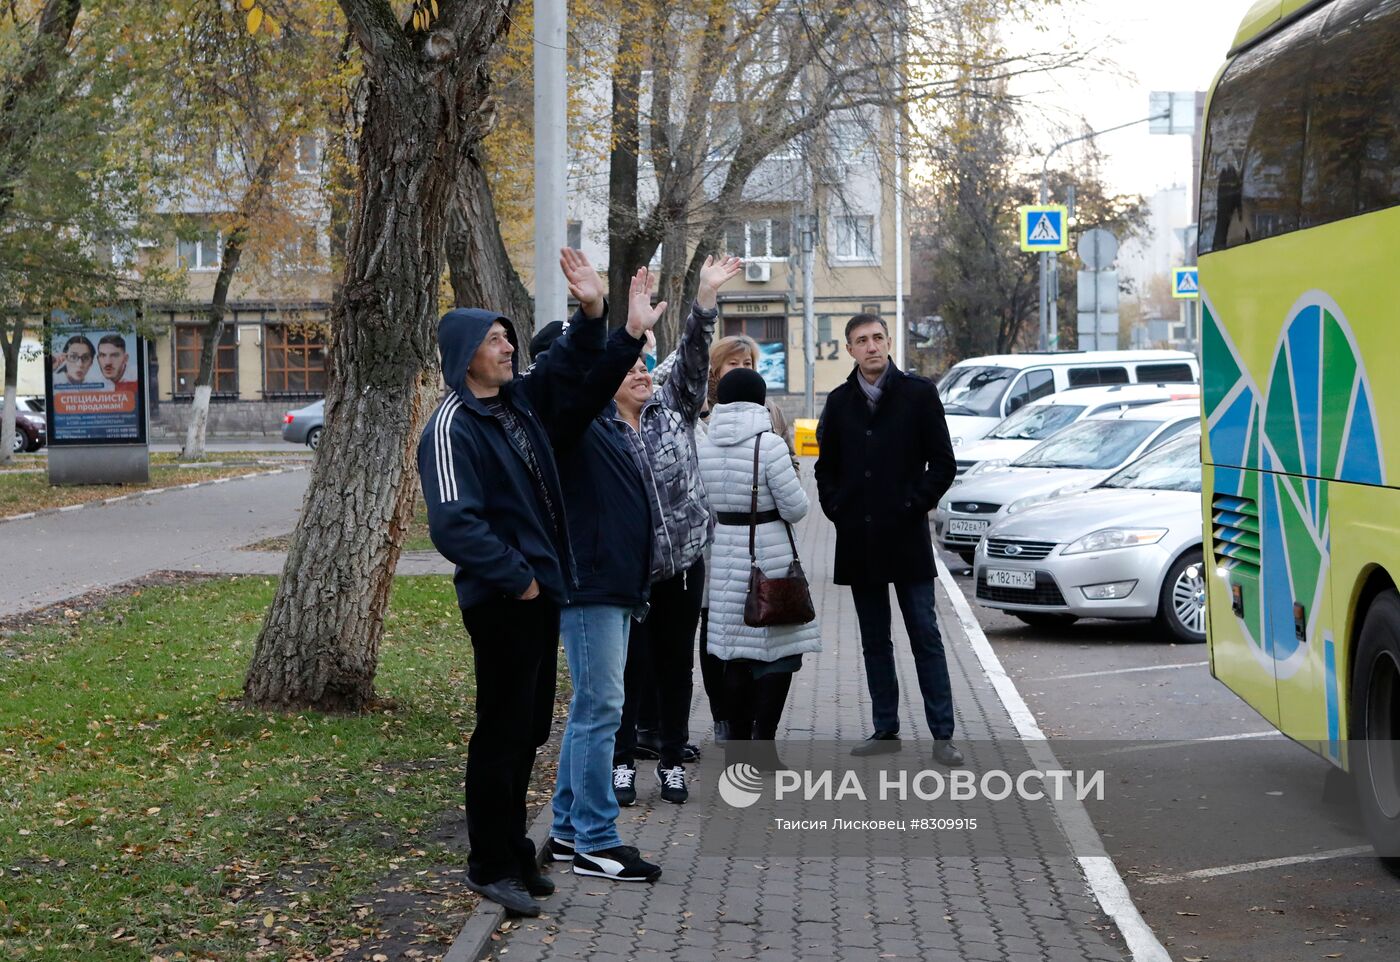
[244,0,511,711]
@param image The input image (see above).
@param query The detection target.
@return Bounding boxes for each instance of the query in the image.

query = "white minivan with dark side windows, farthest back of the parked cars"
[938,350,1201,447]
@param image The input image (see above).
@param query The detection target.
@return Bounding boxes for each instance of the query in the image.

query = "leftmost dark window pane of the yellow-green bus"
[1198,17,1319,253]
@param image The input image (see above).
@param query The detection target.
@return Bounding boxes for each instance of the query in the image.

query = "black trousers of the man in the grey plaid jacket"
[613,559,704,769]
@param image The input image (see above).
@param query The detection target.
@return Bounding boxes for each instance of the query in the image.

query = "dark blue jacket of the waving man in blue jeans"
[542,328,652,606]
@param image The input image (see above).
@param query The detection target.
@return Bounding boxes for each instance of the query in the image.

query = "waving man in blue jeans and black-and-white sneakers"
[531,270,666,882]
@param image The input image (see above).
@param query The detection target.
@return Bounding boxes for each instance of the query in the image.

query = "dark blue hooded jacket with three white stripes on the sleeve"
[419,308,608,608]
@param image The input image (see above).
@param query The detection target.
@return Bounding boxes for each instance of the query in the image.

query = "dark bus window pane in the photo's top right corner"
[1302,0,1400,227]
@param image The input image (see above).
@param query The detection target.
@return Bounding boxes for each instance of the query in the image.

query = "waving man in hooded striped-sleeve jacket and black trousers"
[419,249,635,916]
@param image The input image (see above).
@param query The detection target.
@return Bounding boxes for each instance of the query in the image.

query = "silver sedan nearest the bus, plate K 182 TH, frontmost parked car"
[973,430,1205,643]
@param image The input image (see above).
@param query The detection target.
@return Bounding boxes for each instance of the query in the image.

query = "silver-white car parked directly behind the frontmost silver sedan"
[934,400,1201,564]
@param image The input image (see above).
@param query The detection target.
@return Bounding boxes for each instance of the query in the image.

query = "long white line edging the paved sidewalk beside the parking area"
[938,559,1172,962]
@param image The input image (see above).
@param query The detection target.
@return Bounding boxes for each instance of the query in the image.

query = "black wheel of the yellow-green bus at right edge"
[1350,591,1400,874]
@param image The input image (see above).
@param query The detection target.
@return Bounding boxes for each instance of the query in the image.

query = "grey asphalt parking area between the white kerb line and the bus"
[944,555,1400,962]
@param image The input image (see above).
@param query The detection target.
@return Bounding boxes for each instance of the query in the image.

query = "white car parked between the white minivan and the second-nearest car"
[953,384,1201,477]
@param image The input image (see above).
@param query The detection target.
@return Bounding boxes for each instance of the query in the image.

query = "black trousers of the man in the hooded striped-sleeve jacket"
[462,598,559,885]
